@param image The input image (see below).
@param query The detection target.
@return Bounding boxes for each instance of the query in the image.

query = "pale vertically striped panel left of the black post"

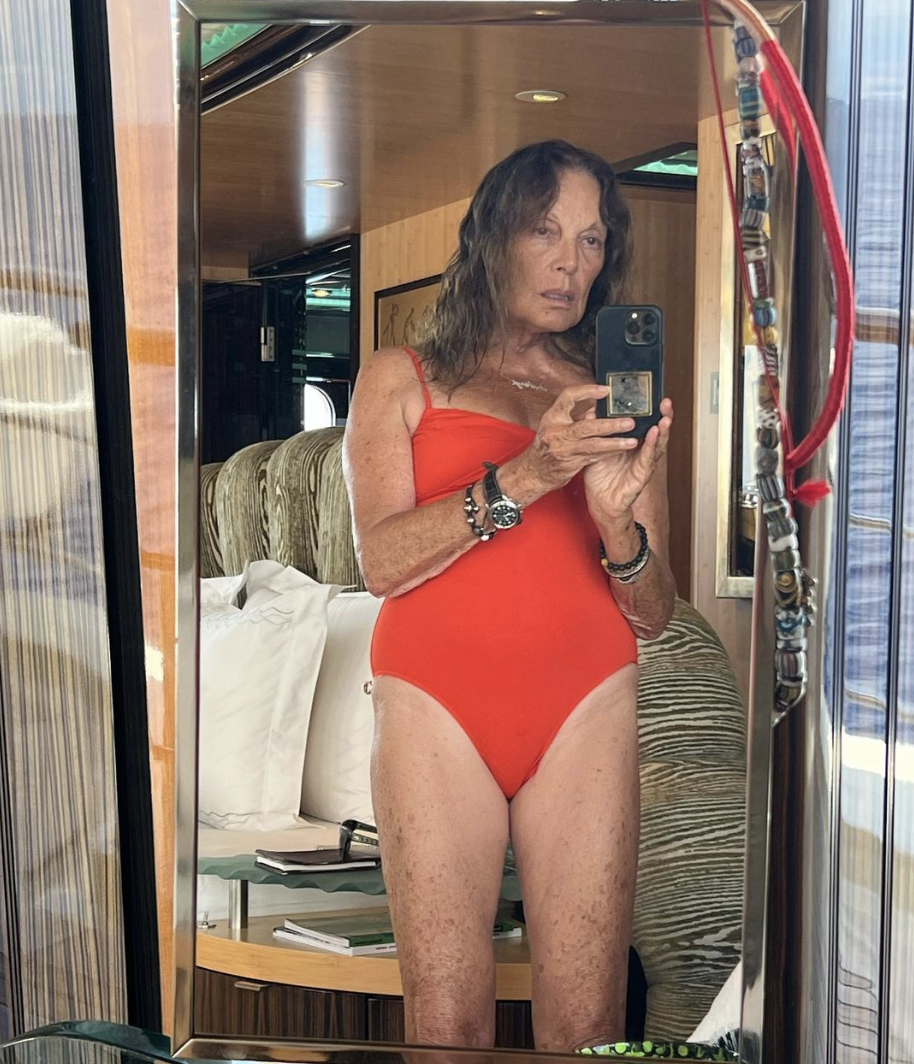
[0,0,127,1028]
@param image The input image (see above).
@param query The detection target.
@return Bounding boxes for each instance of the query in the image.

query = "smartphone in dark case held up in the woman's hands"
[595,304,663,439]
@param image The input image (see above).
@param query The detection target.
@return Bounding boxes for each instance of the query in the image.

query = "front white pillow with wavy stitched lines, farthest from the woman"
[198,561,339,831]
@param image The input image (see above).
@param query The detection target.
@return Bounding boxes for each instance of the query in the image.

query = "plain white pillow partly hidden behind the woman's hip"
[301,592,383,824]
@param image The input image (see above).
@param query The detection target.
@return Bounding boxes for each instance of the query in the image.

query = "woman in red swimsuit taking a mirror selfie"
[345,140,675,1050]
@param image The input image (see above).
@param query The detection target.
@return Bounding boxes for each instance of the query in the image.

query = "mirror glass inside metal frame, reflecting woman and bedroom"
[196,16,791,1050]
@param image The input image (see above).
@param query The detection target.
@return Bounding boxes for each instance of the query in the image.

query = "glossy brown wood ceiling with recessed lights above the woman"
[201,26,733,266]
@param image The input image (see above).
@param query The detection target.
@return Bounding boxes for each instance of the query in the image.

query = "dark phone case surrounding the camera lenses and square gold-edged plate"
[595,303,663,439]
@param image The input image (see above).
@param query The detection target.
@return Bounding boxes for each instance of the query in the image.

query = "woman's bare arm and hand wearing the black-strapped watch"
[343,349,628,598]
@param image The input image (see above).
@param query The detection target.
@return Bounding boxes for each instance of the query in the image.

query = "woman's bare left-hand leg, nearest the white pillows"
[371,676,508,1045]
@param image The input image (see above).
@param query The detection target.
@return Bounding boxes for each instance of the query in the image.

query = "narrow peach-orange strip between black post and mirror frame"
[107,0,178,1032]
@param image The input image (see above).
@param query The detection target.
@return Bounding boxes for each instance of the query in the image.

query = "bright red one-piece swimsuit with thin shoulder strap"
[371,348,637,799]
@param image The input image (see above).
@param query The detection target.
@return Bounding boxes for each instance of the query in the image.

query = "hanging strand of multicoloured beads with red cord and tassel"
[702,0,854,718]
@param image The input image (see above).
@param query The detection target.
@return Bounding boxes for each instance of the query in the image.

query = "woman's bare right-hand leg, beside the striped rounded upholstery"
[511,665,639,1050]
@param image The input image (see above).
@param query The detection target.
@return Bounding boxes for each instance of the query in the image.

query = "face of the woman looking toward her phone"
[506,170,606,333]
